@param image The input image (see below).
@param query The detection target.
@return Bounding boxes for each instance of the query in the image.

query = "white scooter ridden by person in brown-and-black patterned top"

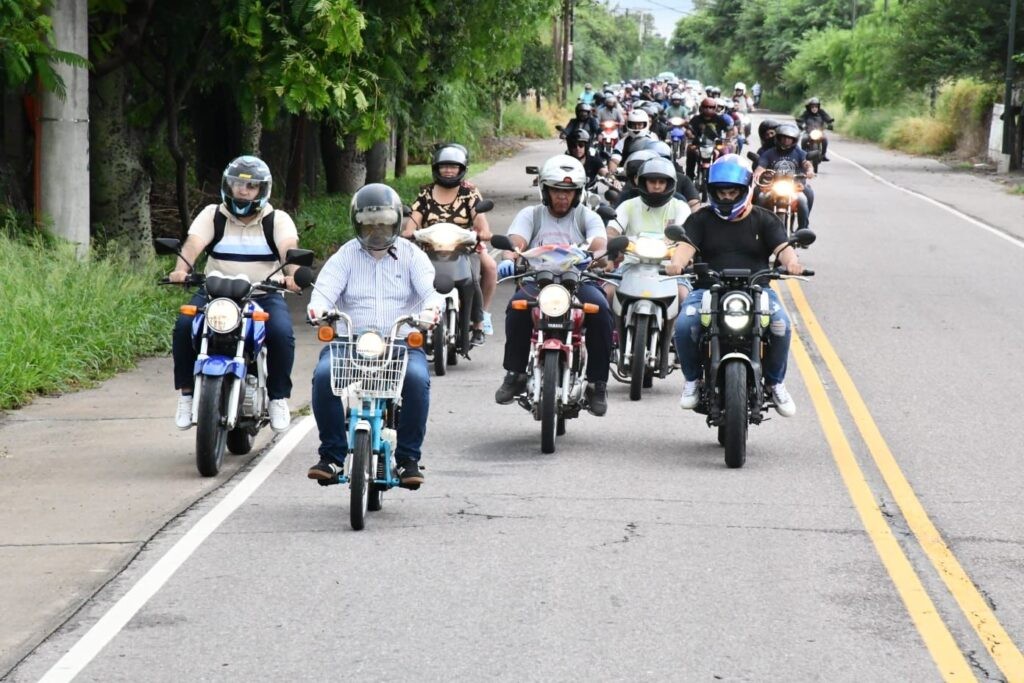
[414,200,495,377]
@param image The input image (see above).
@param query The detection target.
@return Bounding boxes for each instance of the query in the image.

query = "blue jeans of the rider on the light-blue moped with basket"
[312,346,430,465]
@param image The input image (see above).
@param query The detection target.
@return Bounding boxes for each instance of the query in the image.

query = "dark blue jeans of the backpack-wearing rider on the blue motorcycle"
[171,290,295,400]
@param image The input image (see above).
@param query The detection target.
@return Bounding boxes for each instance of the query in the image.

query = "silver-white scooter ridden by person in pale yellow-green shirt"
[609,232,679,400]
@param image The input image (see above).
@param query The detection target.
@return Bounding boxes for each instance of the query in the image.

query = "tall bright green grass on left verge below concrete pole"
[0,233,182,410]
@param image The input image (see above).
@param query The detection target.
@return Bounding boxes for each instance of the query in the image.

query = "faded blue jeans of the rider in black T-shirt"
[675,290,793,386]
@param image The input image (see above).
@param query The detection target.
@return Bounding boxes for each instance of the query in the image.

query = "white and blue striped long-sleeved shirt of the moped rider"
[309,239,444,336]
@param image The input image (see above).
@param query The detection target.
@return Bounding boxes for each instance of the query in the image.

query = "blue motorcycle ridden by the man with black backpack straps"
[154,238,313,477]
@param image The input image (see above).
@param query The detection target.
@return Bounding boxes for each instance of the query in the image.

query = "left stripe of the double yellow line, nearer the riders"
[792,331,977,681]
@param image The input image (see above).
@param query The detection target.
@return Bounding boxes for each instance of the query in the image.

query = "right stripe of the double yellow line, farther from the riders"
[786,280,1024,681]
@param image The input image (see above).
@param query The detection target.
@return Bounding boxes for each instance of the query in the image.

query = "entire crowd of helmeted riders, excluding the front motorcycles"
[161,79,833,488]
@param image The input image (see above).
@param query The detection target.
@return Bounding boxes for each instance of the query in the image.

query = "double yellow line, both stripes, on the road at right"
[786,280,1024,681]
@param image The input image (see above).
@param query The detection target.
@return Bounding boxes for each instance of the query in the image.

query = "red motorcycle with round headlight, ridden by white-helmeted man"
[490,234,629,454]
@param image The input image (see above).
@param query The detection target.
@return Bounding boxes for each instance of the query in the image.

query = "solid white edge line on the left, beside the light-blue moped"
[39,416,315,683]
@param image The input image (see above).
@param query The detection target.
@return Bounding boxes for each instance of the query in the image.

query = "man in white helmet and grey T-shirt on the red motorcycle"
[495,155,611,416]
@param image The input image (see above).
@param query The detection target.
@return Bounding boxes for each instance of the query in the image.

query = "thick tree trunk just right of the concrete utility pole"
[89,67,153,258]
